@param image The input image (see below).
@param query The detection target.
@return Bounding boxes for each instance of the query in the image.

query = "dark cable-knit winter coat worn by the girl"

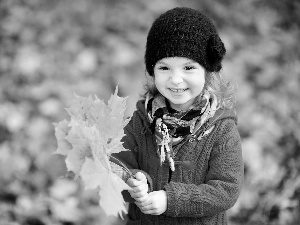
[115,100,244,225]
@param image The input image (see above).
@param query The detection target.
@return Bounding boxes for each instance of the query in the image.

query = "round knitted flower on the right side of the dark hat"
[206,34,226,71]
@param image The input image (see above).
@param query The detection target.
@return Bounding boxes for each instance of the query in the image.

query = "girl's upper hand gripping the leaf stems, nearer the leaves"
[127,172,148,202]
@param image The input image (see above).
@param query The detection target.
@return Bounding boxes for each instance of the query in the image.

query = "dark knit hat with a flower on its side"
[145,7,226,76]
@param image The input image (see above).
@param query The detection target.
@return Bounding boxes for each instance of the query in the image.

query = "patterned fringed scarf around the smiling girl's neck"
[145,92,218,171]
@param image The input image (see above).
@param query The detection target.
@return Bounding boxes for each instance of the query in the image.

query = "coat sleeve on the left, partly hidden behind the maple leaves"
[112,112,153,202]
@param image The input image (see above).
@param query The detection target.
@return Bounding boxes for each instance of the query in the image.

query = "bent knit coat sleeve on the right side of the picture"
[164,119,244,217]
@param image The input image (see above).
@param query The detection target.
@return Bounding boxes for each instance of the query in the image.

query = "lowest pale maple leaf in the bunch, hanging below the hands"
[80,158,130,219]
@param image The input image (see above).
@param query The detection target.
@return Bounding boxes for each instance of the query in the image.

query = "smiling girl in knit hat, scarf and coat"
[114,8,243,225]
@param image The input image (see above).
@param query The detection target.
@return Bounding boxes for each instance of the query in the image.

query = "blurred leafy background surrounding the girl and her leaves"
[0,0,300,225]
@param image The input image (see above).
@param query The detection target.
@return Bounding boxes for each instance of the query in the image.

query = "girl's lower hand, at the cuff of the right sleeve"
[135,190,167,215]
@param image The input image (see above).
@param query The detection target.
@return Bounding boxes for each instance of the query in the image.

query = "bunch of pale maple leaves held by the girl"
[54,87,130,221]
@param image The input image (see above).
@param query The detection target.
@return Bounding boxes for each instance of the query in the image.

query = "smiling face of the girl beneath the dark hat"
[154,57,205,111]
